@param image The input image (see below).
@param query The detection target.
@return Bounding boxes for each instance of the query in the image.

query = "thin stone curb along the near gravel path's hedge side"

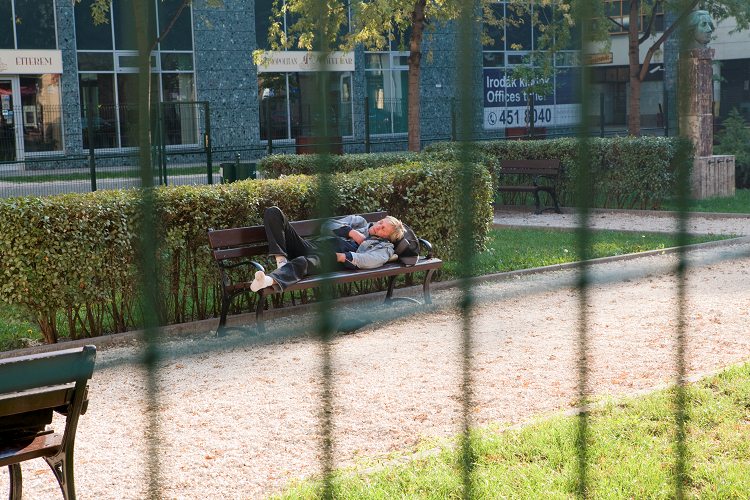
[0,236,750,359]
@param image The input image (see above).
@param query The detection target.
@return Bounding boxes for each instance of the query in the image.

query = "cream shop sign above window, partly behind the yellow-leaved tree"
[258,50,354,73]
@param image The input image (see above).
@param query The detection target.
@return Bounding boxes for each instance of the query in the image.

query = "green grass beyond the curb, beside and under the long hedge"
[0,228,727,350]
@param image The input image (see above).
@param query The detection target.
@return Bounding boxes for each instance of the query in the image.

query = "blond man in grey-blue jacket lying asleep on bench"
[250,207,405,292]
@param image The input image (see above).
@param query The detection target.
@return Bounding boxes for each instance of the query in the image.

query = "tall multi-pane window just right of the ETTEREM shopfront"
[73,0,198,148]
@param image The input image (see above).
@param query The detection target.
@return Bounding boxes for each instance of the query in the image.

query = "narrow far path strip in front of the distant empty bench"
[494,207,750,236]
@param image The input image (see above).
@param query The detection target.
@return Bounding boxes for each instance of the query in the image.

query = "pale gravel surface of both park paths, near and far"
[7,212,750,499]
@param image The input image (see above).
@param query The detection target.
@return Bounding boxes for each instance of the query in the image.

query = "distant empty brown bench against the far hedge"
[497,160,562,214]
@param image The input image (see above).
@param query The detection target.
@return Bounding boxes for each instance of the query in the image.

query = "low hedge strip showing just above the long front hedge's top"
[258,152,418,179]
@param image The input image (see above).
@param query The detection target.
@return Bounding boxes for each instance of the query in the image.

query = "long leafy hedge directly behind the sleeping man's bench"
[0,162,492,342]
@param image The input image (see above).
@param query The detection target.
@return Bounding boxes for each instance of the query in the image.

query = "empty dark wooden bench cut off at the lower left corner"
[0,346,96,500]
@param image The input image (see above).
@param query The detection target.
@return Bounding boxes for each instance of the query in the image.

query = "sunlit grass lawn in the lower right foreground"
[276,364,750,500]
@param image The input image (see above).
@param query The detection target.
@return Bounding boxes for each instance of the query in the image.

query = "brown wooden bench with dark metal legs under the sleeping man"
[208,212,443,335]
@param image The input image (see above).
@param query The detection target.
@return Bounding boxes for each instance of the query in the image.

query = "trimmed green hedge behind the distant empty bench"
[425,137,690,209]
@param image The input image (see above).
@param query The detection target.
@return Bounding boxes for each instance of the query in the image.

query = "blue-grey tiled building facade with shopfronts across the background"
[0,0,750,165]
